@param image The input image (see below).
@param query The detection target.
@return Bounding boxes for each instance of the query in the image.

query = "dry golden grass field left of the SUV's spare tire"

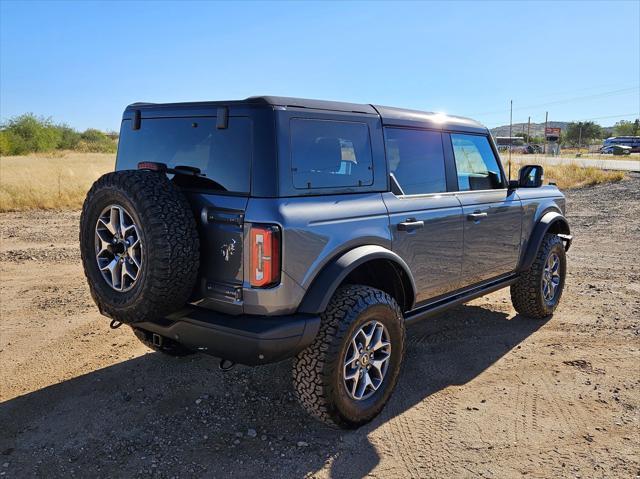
[0,152,115,211]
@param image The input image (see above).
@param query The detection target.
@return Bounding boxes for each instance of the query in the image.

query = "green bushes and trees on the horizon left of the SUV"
[0,113,118,156]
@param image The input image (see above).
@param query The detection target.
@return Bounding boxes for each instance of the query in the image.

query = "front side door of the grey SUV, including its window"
[446,133,522,286]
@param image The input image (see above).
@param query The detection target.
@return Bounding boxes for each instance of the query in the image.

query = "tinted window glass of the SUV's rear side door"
[385,128,447,195]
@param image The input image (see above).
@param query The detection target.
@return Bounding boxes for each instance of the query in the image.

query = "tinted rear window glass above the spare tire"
[117,117,252,193]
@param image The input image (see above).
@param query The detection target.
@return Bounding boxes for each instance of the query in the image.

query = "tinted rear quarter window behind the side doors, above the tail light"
[291,118,373,189]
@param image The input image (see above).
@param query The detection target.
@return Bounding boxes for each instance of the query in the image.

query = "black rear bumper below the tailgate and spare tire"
[135,307,320,366]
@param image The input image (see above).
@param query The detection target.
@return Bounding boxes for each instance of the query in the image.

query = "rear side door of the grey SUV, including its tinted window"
[383,127,463,305]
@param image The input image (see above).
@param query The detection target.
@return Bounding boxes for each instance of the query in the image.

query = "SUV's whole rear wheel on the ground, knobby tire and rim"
[293,285,405,428]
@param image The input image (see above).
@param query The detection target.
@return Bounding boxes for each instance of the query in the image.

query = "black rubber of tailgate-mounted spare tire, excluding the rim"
[80,170,200,324]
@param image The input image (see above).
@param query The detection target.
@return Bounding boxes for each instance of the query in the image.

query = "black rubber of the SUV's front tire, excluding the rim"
[511,233,567,319]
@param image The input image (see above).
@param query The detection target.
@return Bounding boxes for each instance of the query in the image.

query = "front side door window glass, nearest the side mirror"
[451,133,505,191]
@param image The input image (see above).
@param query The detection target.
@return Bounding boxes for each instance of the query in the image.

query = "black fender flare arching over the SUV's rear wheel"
[298,245,416,314]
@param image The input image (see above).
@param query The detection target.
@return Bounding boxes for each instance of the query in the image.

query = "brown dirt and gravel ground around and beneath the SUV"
[0,176,640,478]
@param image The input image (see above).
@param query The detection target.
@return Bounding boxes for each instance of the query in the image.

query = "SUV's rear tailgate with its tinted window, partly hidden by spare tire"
[116,115,253,313]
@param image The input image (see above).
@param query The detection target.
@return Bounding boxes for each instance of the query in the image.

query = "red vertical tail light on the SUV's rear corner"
[250,225,280,288]
